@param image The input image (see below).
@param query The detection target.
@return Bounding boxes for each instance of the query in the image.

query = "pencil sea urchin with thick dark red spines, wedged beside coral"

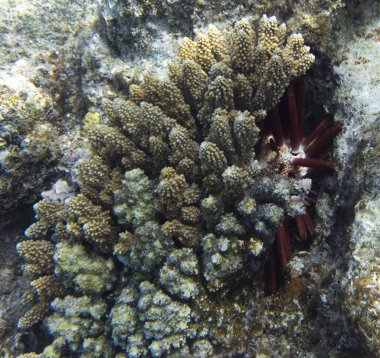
[263,77,341,294]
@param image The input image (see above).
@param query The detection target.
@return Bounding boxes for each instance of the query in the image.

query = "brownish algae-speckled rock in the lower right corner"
[344,198,380,355]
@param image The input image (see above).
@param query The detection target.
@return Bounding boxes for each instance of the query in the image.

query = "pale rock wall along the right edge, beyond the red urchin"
[335,5,380,356]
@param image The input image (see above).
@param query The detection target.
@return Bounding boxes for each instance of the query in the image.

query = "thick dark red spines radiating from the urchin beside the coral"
[267,77,342,294]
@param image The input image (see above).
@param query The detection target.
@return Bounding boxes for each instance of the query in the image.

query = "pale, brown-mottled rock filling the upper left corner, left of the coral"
[0,0,96,216]
